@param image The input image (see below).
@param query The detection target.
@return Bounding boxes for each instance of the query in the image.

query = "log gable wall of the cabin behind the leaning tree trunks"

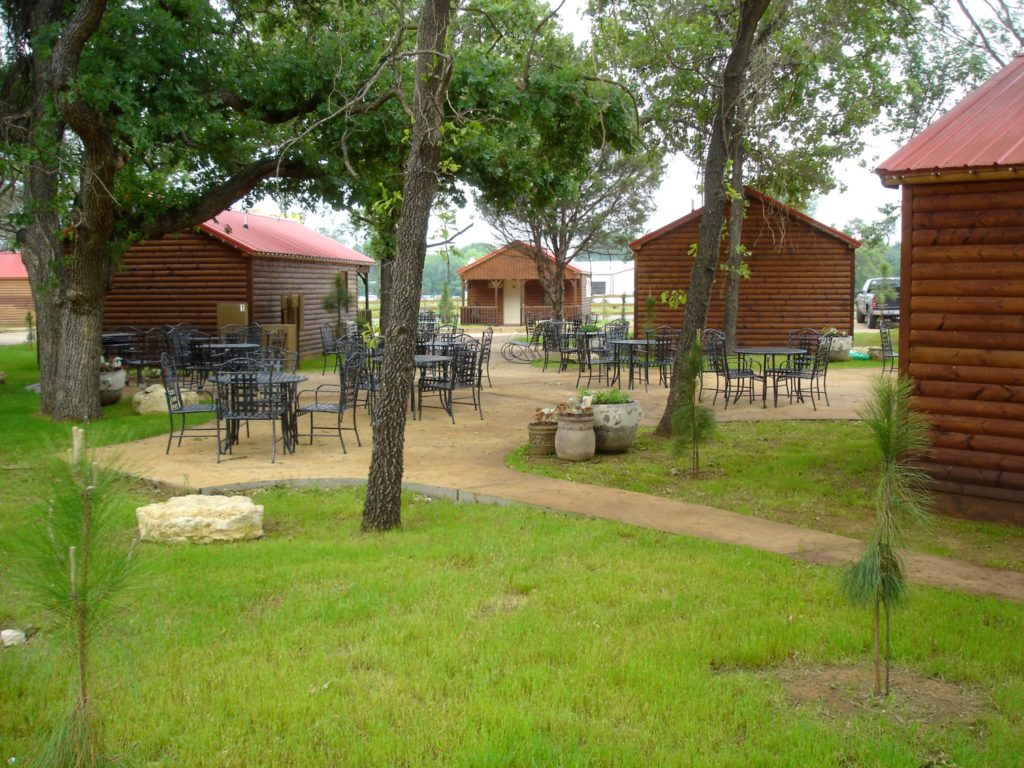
[634,203,854,345]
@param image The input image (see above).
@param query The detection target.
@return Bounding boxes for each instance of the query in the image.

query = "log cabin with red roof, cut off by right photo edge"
[877,55,1024,525]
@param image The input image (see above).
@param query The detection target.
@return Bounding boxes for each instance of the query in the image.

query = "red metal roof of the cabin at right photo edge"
[874,54,1024,186]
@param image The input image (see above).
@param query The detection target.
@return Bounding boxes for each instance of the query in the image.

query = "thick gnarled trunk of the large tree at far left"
[24,0,117,421]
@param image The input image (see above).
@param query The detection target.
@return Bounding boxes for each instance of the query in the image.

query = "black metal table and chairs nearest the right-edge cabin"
[699,328,831,411]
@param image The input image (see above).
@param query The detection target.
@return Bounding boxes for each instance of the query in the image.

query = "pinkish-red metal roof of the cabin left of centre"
[200,211,375,266]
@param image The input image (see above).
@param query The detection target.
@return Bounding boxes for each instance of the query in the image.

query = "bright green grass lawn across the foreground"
[0,348,1024,768]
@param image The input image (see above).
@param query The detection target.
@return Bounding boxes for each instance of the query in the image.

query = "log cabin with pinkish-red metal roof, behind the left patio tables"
[103,211,374,357]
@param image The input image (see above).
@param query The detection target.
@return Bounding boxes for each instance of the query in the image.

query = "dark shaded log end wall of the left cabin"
[103,232,252,332]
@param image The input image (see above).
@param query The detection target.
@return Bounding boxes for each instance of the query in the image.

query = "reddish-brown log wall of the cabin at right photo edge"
[900,180,1024,524]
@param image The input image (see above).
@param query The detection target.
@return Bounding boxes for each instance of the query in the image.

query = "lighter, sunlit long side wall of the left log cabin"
[250,256,358,358]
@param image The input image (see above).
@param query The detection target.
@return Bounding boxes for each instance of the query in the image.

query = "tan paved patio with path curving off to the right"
[101,338,1024,601]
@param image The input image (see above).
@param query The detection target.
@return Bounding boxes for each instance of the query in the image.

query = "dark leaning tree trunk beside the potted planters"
[655,0,771,437]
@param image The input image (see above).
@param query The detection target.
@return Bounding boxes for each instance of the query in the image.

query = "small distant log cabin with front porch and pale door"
[458,241,590,326]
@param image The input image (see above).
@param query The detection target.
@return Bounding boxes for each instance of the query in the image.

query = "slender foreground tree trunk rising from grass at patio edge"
[362,0,452,530]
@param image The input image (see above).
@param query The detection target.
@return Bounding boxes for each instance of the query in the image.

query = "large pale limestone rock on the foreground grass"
[135,495,263,544]
